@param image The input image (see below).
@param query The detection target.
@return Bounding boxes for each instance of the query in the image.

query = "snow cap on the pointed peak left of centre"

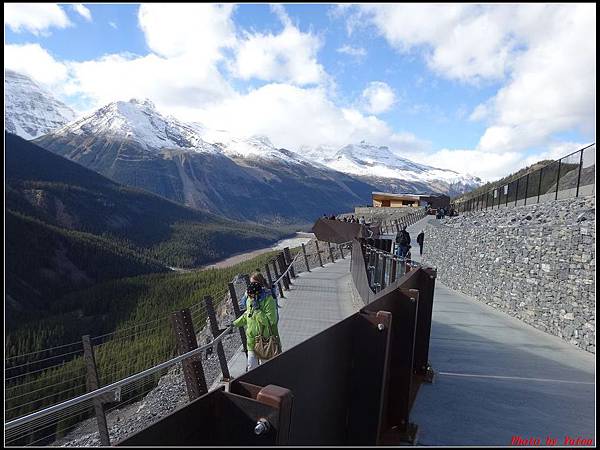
[54,99,218,153]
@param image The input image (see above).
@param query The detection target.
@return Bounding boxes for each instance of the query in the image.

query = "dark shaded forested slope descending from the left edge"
[5,133,286,320]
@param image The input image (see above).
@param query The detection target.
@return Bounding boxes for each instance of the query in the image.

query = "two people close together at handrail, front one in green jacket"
[231,271,281,371]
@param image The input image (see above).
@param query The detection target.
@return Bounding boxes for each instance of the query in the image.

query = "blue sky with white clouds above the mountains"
[5,4,595,178]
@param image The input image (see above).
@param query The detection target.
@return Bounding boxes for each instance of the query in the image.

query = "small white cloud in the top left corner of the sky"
[4,3,71,35]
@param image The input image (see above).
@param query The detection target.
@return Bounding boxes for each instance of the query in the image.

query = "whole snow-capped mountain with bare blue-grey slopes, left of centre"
[34,100,373,224]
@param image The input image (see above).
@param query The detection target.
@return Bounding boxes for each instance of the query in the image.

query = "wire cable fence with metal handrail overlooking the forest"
[5,244,330,446]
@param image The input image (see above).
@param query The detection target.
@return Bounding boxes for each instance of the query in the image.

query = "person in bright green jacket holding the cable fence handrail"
[232,281,281,371]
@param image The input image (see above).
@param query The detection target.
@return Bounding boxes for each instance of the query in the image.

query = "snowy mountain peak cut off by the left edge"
[4,70,76,139]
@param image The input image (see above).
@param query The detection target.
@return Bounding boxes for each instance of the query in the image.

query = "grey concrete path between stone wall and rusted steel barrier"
[408,217,595,446]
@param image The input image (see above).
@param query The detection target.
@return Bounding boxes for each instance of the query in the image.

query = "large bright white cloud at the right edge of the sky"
[478,5,596,155]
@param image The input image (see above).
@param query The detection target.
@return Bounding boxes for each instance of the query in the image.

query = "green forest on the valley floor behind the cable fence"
[5,252,274,424]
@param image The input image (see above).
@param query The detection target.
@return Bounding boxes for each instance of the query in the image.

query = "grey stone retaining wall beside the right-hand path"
[423,196,596,353]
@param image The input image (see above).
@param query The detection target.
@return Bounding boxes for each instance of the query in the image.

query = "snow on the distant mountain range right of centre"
[312,141,479,185]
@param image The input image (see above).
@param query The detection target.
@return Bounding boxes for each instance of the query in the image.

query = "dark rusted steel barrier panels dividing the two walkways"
[118,240,436,446]
